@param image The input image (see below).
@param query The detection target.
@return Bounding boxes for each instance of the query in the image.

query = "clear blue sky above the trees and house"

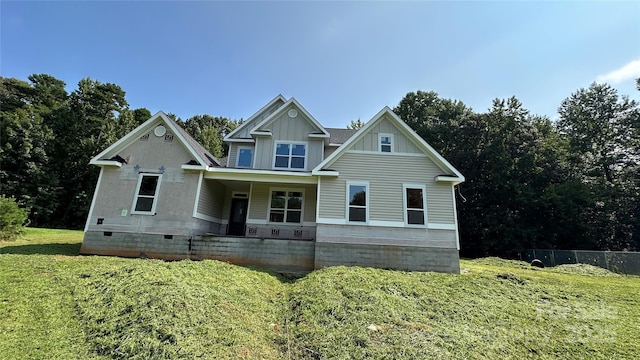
[0,0,640,127]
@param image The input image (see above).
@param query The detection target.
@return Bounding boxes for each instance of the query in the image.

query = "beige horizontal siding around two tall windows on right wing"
[319,152,455,224]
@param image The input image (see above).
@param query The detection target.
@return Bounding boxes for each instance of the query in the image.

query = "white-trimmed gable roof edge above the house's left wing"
[89,111,222,169]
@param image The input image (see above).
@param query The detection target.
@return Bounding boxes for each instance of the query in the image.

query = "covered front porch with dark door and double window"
[193,169,318,241]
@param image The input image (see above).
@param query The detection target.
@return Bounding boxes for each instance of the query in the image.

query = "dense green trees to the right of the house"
[394,85,640,257]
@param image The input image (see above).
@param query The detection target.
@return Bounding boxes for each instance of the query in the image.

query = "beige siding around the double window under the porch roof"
[248,183,317,222]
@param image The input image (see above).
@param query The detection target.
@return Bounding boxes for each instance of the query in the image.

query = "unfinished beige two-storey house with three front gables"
[81,95,464,273]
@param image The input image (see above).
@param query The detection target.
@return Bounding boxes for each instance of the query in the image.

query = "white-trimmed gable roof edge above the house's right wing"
[312,106,464,185]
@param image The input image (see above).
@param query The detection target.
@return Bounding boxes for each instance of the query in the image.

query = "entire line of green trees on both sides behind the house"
[0,74,640,257]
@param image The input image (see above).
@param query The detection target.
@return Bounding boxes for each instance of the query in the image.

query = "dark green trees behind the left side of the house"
[0,74,238,229]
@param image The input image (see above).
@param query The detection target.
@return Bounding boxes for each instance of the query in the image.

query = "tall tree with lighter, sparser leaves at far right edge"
[557,83,640,250]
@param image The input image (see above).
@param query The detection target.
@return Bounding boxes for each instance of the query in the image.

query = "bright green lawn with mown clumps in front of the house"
[0,229,640,359]
